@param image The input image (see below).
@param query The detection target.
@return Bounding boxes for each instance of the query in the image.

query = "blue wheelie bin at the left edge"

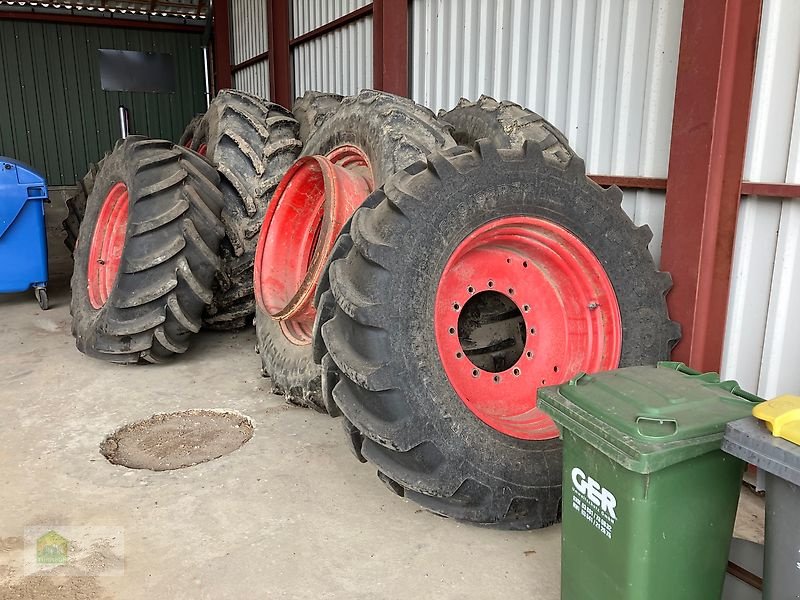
[0,156,47,310]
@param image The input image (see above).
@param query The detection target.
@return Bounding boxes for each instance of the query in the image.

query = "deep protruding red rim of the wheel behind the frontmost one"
[254,146,374,345]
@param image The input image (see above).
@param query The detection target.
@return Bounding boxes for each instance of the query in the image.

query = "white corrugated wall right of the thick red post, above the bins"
[722,0,800,397]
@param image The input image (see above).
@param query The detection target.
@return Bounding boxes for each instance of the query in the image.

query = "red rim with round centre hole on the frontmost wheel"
[434,216,622,440]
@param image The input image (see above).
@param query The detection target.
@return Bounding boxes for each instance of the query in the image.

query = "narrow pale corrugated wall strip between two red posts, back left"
[229,0,269,98]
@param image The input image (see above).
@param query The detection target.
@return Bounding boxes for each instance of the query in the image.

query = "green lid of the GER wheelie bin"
[538,362,762,473]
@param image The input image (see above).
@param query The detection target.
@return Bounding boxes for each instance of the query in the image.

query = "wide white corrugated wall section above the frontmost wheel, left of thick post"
[410,0,683,260]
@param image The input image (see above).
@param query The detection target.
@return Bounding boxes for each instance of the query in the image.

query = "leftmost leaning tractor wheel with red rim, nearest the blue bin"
[70,136,225,363]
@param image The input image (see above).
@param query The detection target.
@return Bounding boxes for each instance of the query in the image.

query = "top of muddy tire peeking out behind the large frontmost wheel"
[439,96,574,165]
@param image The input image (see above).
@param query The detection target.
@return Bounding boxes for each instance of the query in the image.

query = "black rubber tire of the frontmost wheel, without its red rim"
[315,140,680,529]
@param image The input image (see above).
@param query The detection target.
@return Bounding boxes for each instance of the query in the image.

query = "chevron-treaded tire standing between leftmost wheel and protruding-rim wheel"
[198,90,302,330]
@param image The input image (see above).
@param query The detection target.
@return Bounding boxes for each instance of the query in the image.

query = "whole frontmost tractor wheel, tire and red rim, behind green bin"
[315,140,680,529]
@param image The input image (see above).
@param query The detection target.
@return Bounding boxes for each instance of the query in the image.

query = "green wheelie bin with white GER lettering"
[539,362,761,600]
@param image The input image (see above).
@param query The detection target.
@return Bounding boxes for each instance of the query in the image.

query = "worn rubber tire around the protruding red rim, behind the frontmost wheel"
[256,90,455,410]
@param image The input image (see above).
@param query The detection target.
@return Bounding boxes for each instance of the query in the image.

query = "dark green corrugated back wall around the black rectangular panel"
[0,21,205,185]
